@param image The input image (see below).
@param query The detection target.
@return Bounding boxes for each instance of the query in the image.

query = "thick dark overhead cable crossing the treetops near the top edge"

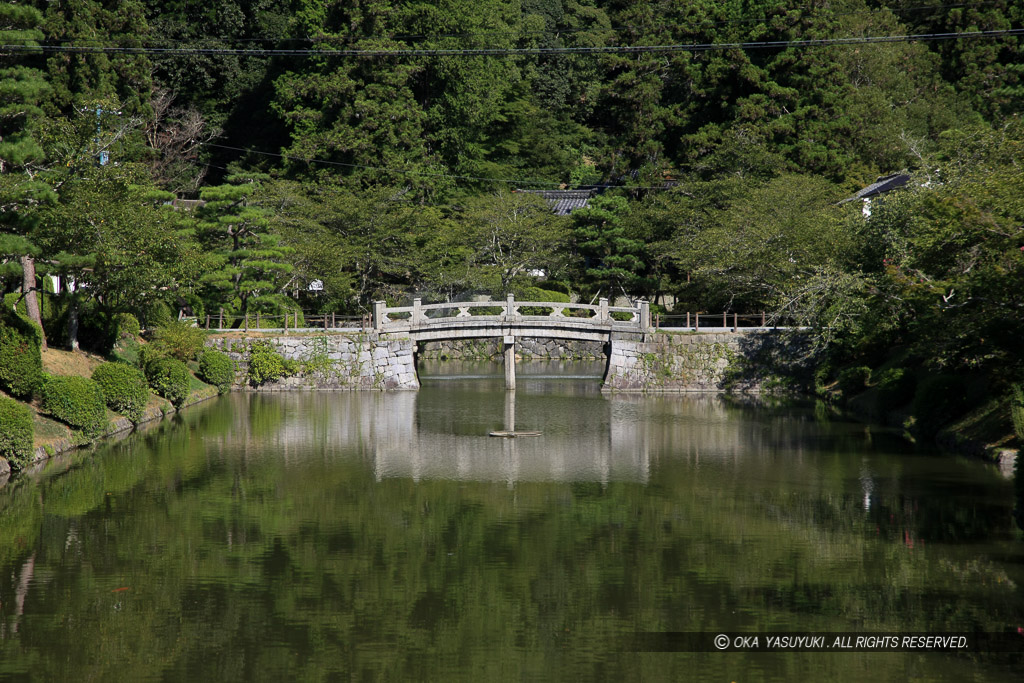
[0,29,1024,57]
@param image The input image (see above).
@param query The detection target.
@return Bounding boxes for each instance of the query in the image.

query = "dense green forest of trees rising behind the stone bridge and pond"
[0,0,1024,444]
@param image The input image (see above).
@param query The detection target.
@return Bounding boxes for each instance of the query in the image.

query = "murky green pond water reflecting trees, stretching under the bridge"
[0,364,1024,681]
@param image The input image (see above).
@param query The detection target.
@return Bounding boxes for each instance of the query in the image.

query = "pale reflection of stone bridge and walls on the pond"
[207,383,823,485]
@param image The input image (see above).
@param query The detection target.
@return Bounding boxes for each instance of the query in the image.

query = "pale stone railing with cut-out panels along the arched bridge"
[373,294,650,332]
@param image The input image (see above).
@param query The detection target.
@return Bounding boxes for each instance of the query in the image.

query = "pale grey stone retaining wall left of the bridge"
[207,334,420,391]
